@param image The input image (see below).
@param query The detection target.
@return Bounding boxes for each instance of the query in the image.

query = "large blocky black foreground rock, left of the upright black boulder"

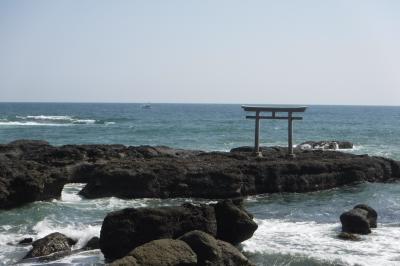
[100,204,217,259]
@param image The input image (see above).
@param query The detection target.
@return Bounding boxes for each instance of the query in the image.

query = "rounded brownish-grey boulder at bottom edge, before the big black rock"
[111,239,197,266]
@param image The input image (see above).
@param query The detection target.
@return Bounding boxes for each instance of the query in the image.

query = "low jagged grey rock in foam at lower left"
[25,233,71,259]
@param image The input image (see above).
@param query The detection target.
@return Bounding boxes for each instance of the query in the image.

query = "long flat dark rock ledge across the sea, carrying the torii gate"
[0,141,400,209]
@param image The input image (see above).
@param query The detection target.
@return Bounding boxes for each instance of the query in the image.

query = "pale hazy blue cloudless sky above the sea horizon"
[0,0,400,105]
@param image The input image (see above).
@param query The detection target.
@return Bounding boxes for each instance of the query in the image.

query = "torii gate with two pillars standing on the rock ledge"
[242,105,307,157]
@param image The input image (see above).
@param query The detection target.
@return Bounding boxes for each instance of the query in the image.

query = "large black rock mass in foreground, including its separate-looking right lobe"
[100,200,257,259]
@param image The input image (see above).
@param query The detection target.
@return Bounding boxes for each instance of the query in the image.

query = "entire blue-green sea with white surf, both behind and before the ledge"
[0,103,400,265]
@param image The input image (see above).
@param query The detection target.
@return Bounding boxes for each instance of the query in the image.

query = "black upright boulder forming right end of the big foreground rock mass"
[214,200,258,245]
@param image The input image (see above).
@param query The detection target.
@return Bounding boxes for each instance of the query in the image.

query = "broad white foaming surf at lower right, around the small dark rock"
[243,219,400,265]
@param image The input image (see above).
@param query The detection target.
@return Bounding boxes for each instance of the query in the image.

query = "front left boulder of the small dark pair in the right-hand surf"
[340,208,371,234]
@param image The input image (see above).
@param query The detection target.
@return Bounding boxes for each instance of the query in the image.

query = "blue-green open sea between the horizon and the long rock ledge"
[0,103,400,158]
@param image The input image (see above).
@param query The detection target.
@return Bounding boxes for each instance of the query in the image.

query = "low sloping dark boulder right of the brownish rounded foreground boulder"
[179,230,252,266]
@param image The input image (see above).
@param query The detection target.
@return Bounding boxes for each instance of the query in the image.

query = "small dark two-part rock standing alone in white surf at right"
[340,204,378,234]
